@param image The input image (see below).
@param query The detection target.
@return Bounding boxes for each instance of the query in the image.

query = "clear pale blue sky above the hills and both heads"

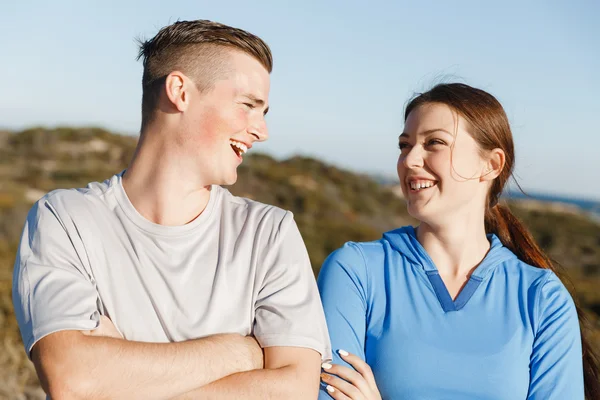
[0,0,600,199]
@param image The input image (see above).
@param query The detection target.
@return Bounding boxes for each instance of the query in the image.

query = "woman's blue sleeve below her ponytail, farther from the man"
[527,272,584,400]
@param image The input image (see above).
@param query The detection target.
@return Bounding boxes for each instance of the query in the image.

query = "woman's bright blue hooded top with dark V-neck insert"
[318,226,584,400]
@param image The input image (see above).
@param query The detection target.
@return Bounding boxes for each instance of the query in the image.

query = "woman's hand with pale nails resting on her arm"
[321,350,381,400]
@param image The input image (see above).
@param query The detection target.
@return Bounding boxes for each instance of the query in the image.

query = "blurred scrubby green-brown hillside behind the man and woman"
[0,128,600,399]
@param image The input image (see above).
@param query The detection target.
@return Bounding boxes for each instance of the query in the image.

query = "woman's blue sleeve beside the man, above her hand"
[317,243,367,400]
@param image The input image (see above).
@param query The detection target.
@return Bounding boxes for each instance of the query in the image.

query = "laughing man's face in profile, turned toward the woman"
[183,51,270,185]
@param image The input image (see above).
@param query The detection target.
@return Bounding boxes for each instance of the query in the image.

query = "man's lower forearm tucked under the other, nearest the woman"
[175,365,319,400]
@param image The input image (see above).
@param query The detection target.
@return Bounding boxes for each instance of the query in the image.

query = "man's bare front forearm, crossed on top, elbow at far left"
[36,332,262,399]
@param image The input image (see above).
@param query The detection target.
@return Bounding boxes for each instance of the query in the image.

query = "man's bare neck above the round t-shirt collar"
[123,130,211,226]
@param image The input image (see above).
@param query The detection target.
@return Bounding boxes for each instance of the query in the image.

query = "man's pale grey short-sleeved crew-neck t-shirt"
[13,173,331,360]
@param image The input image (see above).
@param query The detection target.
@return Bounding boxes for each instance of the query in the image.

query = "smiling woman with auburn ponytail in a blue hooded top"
[318,84,599,400]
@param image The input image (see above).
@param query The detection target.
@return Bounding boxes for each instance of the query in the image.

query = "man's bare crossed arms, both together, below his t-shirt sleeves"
[32,322,320,399]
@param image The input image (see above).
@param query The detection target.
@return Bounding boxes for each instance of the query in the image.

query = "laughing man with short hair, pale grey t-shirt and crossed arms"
[13,21,331,399]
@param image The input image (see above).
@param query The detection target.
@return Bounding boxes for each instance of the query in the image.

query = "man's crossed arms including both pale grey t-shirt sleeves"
[19,203,326,400]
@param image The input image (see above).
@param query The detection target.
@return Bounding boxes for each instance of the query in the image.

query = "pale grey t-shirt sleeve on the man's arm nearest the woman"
[253,212,331,360]
